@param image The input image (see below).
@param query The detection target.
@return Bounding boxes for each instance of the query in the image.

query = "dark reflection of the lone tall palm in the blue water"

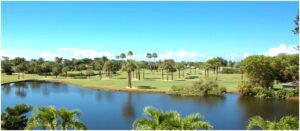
[122,93,135,119]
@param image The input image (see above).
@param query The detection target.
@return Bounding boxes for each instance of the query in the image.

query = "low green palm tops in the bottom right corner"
[247,116,299,130]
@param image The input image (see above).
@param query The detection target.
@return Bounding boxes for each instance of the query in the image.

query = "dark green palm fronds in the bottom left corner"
[1,104,32,130]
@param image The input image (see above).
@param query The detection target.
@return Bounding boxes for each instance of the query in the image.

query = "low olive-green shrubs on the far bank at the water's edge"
[168,80,226,96]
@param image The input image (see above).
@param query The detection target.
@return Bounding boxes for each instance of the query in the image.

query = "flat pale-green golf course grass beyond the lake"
[1,70,246,92]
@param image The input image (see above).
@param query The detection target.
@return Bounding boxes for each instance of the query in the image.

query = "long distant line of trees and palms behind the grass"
[2,51,234,80]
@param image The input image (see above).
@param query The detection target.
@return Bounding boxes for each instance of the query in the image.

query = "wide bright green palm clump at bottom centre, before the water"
[133,107,213,130]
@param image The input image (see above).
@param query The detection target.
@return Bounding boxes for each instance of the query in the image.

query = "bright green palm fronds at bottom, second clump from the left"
[26,106,86,130]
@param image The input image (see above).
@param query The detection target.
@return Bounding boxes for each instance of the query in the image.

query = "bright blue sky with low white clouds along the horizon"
[1,2,298,61]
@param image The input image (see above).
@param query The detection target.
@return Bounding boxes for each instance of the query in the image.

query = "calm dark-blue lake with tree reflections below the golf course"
[1,82,299,129]
